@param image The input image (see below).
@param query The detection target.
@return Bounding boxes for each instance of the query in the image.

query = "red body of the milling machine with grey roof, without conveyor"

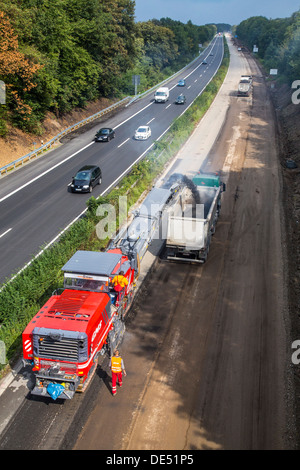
[23,249,135,399]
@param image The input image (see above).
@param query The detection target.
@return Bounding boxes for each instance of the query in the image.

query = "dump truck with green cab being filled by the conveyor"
[166,174,225,263]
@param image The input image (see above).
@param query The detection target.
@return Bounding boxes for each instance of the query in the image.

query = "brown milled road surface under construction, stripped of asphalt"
[0,35,295,454]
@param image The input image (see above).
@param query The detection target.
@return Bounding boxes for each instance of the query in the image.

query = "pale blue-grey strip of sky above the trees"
[135,0,300,26]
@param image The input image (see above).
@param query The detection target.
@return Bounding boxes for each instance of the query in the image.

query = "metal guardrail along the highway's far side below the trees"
[0,39,211,177]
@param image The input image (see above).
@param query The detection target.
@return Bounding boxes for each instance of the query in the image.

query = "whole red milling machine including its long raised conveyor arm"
[22,185,178,399]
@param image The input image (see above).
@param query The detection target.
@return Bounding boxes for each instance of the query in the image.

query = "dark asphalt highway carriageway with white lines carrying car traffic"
[0,37,223,284]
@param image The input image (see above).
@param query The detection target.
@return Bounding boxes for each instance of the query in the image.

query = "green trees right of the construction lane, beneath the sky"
[235,10,300,82]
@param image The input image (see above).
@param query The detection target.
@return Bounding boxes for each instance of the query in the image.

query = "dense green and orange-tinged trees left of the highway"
[0,0,217,136]
